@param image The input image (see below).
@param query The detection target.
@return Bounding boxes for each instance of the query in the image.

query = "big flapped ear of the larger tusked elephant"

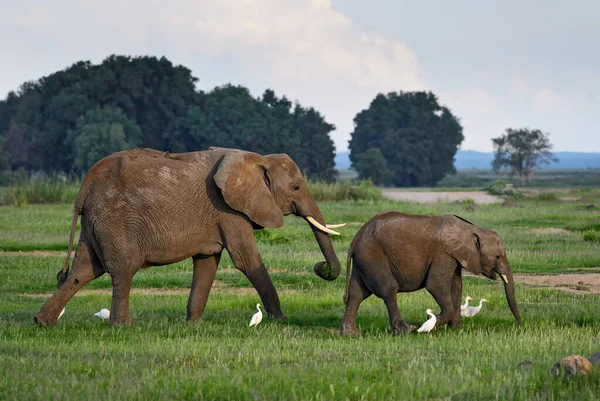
[215,152,283,228]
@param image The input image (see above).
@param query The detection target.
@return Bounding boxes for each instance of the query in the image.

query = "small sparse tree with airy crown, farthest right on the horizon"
[492,128,558,186]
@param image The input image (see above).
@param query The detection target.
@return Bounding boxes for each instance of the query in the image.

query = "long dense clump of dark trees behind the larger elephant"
[0,56,335,180]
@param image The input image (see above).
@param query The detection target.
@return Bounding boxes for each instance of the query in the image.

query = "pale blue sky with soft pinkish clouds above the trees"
[0,0,600,152]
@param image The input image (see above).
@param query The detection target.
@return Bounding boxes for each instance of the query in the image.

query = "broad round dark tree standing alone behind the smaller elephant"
[349,92,464,187]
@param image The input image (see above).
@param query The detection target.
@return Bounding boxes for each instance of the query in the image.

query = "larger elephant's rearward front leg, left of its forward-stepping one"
[187,253,221,320]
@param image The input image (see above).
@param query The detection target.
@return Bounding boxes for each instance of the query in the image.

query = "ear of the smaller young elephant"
[440,216,482,274]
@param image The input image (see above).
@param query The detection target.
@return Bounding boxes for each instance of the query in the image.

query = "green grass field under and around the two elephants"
[0,189,600,400]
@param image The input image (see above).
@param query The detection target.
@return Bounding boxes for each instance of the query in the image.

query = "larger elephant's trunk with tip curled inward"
[296,198,342,281]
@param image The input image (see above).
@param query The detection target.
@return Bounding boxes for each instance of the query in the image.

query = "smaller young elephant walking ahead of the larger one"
[341,212,521,335]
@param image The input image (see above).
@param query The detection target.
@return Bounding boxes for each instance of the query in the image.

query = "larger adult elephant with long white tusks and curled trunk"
[35,148,340,326]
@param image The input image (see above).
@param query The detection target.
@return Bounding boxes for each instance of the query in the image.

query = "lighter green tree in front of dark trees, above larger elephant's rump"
[71,106,141,172]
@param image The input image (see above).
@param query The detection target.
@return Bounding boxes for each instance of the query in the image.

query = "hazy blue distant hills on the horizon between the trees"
[334,150,600,170]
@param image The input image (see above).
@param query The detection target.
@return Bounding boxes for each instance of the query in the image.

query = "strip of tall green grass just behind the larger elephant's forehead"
[308,180,383,202]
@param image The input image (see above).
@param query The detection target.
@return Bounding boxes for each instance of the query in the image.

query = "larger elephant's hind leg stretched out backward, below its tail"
[34,238,104,327]
